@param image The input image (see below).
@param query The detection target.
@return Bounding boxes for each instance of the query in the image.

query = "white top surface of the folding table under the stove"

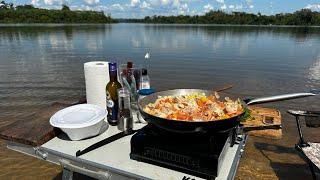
[41,119,242,180]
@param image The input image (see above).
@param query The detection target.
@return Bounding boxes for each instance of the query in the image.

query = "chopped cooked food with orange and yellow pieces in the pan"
[144,92,243,121]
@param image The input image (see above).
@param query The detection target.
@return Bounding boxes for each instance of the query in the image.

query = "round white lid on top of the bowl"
[50,104,107,128]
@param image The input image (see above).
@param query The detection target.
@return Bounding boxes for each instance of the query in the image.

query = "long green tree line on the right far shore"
[136,9,320,26]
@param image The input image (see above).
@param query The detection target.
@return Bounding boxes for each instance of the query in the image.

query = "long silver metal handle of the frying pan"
[244,92,317,105]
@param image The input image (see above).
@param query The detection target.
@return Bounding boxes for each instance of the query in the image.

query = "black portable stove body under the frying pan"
[130,125,237,179]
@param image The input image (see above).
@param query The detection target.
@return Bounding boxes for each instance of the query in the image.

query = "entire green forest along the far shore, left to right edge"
[0,1,320,26]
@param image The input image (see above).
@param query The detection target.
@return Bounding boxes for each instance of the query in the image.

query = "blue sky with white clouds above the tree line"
[6,0,320,18]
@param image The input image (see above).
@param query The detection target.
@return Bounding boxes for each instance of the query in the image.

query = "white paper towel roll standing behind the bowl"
[84,61,109,109]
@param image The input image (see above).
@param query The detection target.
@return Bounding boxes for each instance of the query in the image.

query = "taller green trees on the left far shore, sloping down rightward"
[0,1,115,23]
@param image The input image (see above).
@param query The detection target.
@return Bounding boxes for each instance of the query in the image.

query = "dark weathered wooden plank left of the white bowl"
[0,103,70,146]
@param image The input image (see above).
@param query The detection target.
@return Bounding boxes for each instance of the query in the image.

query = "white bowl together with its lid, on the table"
[50,104,107,140]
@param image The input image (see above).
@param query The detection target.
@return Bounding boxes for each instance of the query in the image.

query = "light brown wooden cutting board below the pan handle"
[241,106,282,139]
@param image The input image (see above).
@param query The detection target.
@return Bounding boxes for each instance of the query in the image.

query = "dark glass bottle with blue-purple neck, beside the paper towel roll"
[106,63,121,126]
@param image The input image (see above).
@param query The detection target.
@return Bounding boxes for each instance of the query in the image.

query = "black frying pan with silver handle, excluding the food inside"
[138,89,319,133]
